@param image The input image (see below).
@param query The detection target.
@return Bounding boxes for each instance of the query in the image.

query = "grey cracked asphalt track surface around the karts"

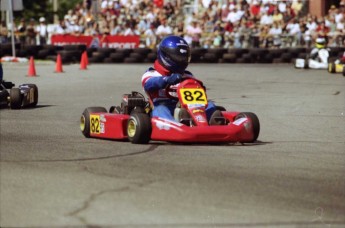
[0,63,345,227]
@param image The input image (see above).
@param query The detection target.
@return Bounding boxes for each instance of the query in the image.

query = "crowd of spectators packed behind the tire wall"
[0,0,345,48]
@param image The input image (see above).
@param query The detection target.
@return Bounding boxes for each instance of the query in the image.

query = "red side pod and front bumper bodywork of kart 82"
[90,111,254,142]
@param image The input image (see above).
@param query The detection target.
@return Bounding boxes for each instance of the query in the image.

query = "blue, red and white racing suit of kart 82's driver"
[141,60,216,121]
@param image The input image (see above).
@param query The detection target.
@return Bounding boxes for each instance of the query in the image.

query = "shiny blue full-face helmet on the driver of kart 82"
[157,36,190,73]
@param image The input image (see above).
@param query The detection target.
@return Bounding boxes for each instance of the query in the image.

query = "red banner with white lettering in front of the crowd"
[51,35,140,49]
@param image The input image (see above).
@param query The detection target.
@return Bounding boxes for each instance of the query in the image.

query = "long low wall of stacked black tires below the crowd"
[0,44,345,64]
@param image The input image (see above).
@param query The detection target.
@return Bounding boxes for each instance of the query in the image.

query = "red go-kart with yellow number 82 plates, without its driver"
[80,78,260,144]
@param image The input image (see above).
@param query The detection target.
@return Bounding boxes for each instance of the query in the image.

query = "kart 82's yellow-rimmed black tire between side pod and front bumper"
[127,112,152,144]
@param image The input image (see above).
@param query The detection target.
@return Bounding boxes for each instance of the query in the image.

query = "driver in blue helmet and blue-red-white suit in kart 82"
[141,35,221,124]
